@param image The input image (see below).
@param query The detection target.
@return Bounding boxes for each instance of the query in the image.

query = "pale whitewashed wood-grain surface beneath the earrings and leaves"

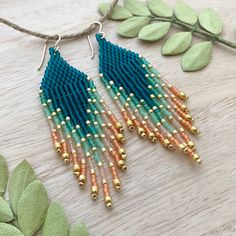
[0,0,236,236]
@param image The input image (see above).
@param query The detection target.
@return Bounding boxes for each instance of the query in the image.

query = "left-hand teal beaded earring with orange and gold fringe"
[39,47,126,207]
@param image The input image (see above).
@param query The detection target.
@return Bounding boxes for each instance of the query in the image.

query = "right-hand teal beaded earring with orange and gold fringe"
[96,33,201,163]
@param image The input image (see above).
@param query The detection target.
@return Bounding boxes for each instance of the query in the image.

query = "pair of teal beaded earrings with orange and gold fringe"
[39,22,201,207]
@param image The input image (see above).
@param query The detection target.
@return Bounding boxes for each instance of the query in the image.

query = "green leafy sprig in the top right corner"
[99,0,236,71]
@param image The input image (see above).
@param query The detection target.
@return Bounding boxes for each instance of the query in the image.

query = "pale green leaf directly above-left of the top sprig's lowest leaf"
[162,32,192,56]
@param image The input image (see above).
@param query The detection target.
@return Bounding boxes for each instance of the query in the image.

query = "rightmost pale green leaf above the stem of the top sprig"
[199,8,223,35]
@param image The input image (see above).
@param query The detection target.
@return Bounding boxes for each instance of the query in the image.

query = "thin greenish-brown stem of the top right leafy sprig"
[150,16,236,49]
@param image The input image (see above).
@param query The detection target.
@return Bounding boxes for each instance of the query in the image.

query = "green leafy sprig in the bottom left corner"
[0,155,89,236]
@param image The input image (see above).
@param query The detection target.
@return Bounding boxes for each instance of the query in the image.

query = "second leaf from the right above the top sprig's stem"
[174,1,197,25]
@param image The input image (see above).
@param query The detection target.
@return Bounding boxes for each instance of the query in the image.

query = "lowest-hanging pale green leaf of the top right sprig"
[182,41,212,71]
